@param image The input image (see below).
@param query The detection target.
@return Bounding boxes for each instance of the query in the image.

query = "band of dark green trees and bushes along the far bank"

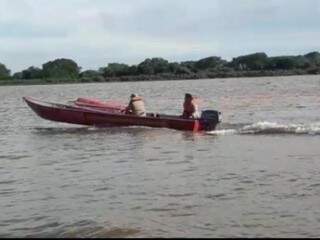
[0,52,320,84]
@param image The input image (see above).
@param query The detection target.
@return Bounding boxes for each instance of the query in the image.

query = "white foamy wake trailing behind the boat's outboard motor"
[207,122,320,135]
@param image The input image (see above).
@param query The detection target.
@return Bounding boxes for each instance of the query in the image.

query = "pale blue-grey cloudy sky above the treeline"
[0,0,320,72]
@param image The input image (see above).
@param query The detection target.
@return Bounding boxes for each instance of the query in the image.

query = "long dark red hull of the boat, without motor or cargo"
[23,97,218,131]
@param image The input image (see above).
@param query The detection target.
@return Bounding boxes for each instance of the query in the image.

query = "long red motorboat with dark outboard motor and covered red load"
[23,97,221,131]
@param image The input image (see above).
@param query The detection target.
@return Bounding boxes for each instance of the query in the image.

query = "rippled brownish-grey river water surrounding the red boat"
[0,76,320,237]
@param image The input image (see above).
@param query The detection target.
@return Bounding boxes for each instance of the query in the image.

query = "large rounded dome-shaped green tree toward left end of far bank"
[42,58,81,79]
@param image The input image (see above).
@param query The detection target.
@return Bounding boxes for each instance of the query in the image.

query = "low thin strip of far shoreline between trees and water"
[0,69,320,86]
